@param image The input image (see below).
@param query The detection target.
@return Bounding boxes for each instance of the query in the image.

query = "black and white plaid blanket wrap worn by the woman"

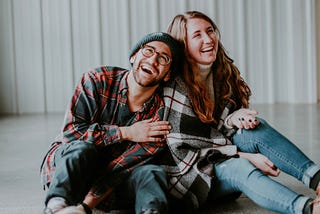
[163,77,234,208]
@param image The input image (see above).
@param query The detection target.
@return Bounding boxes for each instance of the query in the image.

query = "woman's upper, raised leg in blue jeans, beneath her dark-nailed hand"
[232,118,320,189]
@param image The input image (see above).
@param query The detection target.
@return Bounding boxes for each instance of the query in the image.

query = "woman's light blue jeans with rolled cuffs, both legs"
[210,118,320,213]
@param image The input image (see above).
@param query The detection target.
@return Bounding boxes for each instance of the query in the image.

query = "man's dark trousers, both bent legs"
[45,141,168,214]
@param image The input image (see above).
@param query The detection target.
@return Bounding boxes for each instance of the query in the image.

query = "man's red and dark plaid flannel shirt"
[41,66,166,189]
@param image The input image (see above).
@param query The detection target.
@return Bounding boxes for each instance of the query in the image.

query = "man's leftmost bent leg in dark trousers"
[45,141,99,211]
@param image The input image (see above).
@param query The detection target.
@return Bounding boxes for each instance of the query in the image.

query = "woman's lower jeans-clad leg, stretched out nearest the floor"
[208,158,310,214]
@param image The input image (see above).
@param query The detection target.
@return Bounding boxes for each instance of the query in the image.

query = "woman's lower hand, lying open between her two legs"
[238,152,280,177]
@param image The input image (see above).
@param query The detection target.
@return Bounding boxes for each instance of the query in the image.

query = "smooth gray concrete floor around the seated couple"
[0,104,320,214]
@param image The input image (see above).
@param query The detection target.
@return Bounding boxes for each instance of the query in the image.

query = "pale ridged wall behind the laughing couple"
[0,0,319,114]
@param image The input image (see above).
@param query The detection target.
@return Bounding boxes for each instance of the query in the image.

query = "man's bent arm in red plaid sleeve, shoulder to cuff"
[62,71,121,145]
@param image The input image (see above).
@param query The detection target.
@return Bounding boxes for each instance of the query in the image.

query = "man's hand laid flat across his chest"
[120,119,171,143]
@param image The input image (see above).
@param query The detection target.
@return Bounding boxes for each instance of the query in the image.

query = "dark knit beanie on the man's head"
[130,32,183,73]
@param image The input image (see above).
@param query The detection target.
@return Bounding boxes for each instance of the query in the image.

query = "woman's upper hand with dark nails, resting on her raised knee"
[227,108,259,129]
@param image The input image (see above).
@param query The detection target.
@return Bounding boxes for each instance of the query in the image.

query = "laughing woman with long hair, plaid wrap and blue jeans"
[164,11,320,213]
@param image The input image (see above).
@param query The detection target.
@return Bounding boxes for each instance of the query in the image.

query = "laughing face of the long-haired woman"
[187,18,218,65]
